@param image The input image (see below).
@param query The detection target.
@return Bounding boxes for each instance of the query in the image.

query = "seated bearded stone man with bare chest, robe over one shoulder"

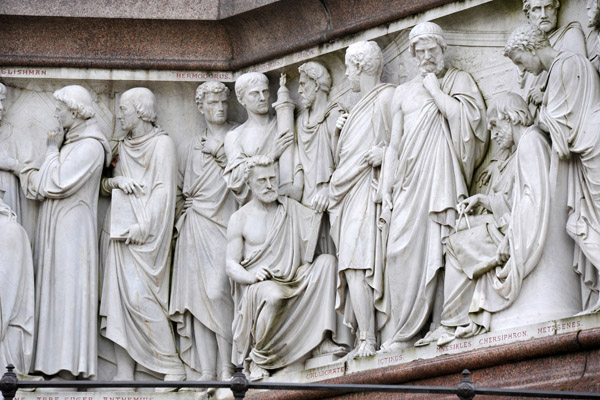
[227,156,336,380]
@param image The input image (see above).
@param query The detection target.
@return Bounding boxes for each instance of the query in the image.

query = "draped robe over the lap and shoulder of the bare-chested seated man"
[232,197,336,369]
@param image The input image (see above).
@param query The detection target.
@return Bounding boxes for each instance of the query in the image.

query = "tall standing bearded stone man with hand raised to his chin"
[377,22,488,351]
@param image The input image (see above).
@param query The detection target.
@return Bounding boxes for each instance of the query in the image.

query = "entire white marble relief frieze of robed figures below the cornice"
[0,0,600,386]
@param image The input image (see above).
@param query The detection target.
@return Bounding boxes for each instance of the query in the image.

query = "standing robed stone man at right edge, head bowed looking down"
[504,25,600,312]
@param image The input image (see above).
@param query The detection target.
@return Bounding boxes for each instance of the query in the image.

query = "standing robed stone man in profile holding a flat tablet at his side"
[100,88,185,380]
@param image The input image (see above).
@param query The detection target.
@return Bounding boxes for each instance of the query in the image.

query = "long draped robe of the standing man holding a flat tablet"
[100,127,185,375]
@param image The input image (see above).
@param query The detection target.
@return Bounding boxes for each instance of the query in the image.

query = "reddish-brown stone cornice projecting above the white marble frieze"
[0,0,454,71]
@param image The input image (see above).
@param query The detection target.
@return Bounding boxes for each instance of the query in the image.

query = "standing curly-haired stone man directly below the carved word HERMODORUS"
[170,82,237,380]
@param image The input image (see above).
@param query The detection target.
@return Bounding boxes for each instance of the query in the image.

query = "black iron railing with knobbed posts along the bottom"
[0,365,600,400]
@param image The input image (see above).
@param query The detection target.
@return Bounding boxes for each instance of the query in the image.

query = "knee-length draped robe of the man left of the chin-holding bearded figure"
[329,83,394,328]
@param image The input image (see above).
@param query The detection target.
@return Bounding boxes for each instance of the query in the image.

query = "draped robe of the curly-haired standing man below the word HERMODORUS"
[170,130,237,371]
